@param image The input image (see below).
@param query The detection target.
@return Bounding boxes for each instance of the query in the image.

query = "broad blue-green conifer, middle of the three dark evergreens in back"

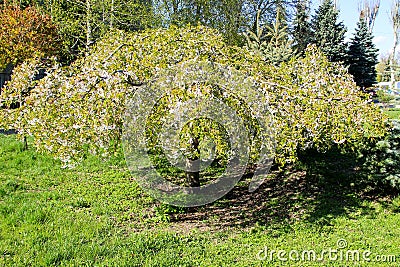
[311,0,347,62]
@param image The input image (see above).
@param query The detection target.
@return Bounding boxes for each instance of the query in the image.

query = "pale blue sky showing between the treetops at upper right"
[313,0,393,56]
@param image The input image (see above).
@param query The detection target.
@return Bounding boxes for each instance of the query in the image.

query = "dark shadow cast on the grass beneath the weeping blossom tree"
[166,149,394,229]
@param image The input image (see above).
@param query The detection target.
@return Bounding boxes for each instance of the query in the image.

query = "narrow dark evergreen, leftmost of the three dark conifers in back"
[292,0,312,55]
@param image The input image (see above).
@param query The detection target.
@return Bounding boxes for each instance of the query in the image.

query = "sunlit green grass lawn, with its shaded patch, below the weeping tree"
[0,135,400,266]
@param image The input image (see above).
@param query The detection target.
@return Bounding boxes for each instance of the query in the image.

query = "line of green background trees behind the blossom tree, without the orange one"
[0,0,379,88]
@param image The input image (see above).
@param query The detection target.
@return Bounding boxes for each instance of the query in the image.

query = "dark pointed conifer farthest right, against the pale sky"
[347,19,378,89]
